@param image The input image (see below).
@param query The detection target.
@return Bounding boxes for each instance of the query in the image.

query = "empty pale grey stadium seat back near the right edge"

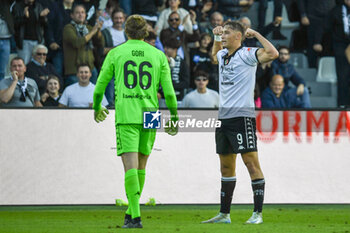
[316,57,337,83]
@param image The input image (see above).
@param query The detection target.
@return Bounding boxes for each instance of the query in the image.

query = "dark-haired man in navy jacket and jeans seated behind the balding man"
[272,46,311,107]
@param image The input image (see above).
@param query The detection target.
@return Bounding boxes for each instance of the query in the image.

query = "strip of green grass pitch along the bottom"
[0,205,350,233]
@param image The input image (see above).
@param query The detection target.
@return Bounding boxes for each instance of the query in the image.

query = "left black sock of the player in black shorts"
[220,176,236,214]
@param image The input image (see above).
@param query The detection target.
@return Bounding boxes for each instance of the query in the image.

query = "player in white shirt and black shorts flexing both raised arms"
[202,21,278,224]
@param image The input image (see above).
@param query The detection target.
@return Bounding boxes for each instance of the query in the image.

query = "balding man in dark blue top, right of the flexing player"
[261,74,307,108]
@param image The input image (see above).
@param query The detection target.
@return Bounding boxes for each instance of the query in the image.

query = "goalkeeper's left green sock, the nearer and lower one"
[125,168,141,218]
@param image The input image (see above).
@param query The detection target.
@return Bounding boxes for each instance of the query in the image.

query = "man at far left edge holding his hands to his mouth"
[0,57,42,107]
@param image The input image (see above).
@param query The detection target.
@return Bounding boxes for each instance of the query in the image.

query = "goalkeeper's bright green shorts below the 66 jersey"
[116,124,156,156]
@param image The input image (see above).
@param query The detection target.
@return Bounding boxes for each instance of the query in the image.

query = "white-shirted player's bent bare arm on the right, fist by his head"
[245,28,278,63]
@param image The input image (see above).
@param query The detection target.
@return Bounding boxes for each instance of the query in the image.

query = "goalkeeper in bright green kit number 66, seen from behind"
[93,15,178,228]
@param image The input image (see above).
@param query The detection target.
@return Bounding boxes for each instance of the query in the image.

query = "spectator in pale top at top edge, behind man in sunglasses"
[155,0,193,35]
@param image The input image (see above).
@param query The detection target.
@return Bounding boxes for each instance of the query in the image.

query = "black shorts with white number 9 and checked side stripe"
[215,117,258,155]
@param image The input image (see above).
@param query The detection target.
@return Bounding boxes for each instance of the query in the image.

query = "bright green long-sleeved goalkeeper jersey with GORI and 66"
[93,40,177,124]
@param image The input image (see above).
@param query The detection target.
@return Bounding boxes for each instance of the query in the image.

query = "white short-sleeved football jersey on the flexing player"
[216,47,259,119]
